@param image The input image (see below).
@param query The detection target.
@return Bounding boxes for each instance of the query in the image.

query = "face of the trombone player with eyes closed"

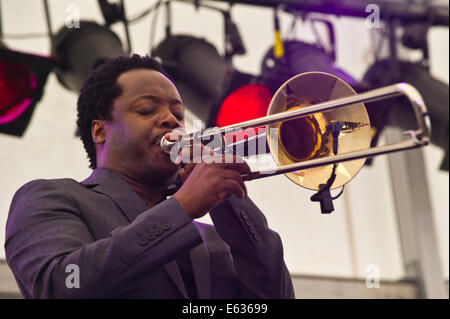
[102,69,184,186]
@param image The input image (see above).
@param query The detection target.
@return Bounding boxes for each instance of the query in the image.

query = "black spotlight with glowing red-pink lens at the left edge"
[0,47,55,136]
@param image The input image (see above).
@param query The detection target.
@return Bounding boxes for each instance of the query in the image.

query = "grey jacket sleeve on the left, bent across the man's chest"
[5,180,201,298]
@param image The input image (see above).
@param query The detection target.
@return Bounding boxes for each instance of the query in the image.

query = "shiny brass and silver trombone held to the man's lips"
[161,72,431,191]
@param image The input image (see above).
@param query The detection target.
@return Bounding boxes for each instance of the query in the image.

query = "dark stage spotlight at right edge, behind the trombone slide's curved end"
[364,60,449,171]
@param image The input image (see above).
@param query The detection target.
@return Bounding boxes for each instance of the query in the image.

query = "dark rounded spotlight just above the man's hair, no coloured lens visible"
[52,21,127,92]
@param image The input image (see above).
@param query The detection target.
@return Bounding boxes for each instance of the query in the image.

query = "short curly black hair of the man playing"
[77,54,170,169]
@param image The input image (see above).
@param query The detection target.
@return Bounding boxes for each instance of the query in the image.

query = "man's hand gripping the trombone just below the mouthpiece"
[173,154,250,219]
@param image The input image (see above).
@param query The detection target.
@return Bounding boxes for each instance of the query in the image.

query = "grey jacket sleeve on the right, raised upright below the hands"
[210,195,295,299]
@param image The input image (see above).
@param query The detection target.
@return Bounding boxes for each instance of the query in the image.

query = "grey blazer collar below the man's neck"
[81,168,148,222]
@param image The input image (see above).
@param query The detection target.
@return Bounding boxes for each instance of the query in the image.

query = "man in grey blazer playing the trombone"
[5,55,294,298]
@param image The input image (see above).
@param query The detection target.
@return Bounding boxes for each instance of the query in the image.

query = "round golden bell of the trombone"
[266,72,371,190]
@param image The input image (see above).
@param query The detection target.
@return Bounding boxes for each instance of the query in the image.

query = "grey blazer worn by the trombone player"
[5,169,294,299]
